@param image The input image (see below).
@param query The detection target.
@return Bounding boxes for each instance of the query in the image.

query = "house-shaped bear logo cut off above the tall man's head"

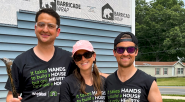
[39,0,56,11]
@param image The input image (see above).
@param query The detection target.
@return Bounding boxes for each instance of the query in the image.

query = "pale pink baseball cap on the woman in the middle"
[72,40,94,56]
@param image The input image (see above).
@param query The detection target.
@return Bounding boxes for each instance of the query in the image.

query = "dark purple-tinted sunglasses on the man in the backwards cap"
[115,46,137,54]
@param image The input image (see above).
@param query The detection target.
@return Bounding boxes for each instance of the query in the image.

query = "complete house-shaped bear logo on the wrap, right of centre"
[102,3,114,20]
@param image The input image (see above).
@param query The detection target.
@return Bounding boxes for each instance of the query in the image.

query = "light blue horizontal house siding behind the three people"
[0,11,131,102]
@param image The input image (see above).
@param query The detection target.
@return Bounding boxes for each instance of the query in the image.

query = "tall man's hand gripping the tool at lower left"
[6,91,22,102]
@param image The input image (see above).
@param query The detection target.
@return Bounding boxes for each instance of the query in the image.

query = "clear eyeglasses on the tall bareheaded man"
[36,22,58,29]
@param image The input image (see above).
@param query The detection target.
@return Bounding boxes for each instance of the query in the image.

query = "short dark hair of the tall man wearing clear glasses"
[35,8,60,28]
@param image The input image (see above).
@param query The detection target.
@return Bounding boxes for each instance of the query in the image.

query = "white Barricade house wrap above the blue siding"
[0,0,132,25]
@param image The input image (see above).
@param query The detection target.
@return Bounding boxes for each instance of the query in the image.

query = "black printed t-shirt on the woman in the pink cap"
[60,74,106,102]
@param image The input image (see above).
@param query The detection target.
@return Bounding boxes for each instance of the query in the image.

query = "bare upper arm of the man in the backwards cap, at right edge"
[148,81,162,102]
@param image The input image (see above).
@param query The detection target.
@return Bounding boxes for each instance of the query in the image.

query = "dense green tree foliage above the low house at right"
[135,0,185,61]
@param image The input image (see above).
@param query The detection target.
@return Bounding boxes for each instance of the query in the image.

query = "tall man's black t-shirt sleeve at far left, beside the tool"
[5,63,23,93]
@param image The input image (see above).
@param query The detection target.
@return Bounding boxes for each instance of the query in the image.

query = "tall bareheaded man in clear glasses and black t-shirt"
[5,9,76,102]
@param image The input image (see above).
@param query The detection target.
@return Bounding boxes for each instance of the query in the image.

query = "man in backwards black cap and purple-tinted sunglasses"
[105,32,162,102]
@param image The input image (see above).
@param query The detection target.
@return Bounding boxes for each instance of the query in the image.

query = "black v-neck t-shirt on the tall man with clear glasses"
[5,47,76,102]
